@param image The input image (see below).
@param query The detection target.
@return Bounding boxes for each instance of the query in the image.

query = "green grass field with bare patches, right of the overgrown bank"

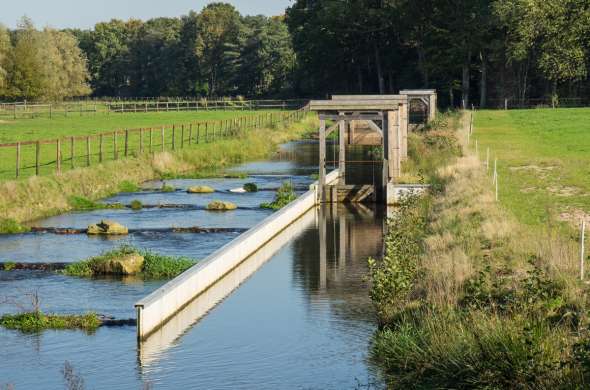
[478,109,590,225]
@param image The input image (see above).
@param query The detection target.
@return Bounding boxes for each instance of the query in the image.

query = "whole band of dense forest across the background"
[0,0,590,106]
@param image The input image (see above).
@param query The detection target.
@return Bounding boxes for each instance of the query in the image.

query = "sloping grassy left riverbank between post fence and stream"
[0,116,316,233]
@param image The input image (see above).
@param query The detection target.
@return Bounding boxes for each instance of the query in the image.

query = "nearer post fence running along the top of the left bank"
[0,107,307,179]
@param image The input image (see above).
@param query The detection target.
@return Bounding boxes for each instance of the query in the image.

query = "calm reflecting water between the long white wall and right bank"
[139,205,383,389]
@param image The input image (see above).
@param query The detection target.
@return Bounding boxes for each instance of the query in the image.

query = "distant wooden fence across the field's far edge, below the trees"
[0,99,307,119]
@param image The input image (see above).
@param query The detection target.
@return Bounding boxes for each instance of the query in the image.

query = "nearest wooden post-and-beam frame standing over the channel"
[309,95,408,202]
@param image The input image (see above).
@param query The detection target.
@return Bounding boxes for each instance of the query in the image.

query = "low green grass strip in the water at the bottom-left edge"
[0,312,101,333]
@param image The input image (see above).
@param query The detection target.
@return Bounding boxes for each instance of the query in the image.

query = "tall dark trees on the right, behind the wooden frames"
[286,0,590,106]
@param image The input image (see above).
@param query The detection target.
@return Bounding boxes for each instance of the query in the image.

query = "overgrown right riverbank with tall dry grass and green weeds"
[372,112,590,388]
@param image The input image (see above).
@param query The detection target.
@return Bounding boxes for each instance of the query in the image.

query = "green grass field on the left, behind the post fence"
[0,111,286,180]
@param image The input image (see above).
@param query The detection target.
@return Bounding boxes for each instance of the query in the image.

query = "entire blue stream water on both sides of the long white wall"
[0,143,383,389]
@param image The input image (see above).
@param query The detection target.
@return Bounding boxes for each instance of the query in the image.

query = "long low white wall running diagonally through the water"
[135,170,338,340]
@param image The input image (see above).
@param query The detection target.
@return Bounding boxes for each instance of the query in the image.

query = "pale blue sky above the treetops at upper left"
[0,0,291,28]
